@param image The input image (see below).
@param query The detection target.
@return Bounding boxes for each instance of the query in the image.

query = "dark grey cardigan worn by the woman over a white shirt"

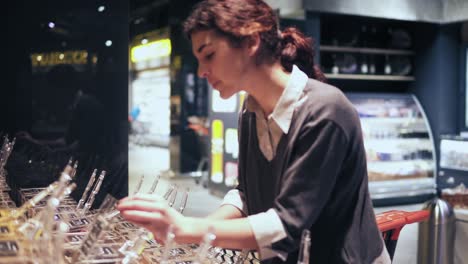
[237,80,383,263]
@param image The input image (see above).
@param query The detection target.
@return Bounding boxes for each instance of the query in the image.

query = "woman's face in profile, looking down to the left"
[191,30,249,99]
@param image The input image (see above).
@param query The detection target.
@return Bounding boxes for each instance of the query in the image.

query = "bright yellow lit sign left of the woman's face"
[130,39,172,63]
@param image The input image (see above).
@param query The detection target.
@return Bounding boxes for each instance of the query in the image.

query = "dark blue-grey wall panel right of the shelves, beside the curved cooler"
[410,21,461,173]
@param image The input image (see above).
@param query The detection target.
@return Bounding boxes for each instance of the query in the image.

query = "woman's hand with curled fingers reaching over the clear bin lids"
[117,194,188,242]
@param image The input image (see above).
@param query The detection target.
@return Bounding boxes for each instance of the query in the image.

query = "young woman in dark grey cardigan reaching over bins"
[119,0,390,263]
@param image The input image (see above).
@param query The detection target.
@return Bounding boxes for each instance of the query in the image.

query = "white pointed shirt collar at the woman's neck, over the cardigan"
[246,65,309,134]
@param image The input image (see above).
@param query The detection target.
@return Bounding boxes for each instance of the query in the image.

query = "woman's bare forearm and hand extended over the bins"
[117,194,259,249]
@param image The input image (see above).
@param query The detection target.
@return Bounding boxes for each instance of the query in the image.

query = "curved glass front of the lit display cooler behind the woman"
[347,93,436,205]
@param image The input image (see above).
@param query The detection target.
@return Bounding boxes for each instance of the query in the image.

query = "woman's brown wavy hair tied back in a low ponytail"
[184,0,326,81]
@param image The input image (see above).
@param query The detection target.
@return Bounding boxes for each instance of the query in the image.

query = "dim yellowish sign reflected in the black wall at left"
[31,50,88,67]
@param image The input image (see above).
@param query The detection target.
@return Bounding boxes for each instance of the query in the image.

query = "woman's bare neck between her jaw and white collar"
[246,63,291,117]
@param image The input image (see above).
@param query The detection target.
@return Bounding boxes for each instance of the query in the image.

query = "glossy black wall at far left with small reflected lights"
[0,0,129,200]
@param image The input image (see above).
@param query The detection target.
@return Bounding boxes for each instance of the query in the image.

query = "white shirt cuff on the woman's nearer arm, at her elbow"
[248,209,288,261]
